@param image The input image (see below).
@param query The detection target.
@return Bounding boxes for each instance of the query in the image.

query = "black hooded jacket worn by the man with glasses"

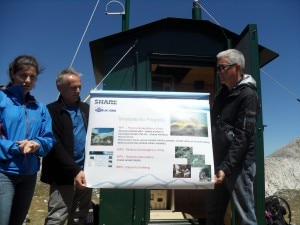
[211,74,260,176]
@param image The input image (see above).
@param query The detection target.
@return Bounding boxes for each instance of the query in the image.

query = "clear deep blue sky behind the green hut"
[0,0,300,156]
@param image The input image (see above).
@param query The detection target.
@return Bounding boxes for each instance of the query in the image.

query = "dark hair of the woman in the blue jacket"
[9,55,44,79]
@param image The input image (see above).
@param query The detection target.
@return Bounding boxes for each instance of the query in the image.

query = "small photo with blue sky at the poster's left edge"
[91,128,114,146]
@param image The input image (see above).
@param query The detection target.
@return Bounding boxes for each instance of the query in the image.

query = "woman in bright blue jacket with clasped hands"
[0,55,55,225]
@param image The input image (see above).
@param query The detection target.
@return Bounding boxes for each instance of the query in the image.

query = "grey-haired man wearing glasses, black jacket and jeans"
[206,49,260,225]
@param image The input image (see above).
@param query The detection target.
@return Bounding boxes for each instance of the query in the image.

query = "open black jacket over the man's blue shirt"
[41,97,89,185]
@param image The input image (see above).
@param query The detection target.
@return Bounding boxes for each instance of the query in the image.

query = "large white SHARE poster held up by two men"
[84,91,214,189]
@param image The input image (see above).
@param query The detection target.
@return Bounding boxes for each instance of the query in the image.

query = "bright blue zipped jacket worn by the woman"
[0,85,55,175]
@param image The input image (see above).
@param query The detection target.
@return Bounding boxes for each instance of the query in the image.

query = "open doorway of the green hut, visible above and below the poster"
[150,58,216,221]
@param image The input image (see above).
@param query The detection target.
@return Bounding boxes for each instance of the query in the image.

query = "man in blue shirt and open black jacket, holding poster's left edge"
[41,69,92,225]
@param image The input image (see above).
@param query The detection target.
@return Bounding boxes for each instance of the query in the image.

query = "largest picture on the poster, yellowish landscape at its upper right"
[170,112,208,137]
